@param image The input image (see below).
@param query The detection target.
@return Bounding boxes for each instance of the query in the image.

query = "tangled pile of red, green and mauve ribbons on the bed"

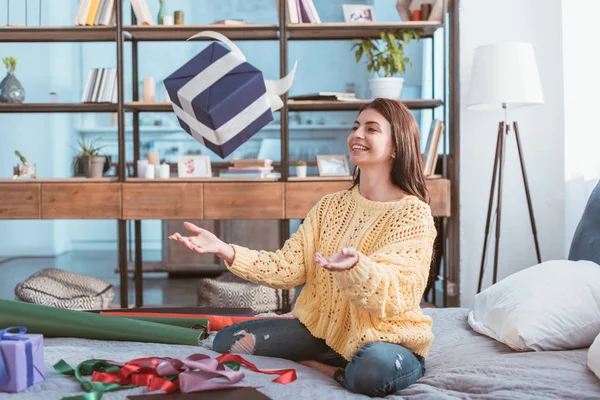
[54,354,296,400]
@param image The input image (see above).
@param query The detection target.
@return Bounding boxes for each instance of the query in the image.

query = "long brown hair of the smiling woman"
[352,98,429,203]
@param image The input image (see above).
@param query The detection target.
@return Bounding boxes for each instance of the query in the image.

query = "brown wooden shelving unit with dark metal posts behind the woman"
[0,0,459,307]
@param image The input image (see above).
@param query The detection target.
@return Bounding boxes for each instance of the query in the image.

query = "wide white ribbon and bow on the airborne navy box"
[171,31,297,146]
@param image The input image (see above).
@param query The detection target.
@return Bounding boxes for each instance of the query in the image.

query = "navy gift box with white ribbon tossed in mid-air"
[164,31,296,158]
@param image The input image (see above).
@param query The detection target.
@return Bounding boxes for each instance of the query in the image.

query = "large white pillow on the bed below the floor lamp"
[468,260,600,351]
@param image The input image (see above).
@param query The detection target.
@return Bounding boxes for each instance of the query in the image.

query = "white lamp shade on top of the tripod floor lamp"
[468,42,544,110]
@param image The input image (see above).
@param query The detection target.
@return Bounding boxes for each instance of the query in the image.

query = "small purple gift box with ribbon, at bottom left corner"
[0,327,46,392]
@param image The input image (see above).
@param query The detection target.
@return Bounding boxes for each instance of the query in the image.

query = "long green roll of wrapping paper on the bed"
[0,300,204,346]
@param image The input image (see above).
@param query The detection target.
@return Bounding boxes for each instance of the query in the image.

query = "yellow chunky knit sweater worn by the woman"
[226,186,436,360]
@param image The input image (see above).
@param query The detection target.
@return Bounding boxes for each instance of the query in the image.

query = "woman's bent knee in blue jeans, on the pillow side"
[344,343,423,396]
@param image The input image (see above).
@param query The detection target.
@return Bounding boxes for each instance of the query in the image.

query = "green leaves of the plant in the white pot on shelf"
[352,29,422,77]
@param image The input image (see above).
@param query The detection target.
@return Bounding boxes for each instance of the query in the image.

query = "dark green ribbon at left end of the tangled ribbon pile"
[54,360,135,400]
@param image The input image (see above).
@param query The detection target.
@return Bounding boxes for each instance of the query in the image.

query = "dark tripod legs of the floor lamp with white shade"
[477,120,542,293]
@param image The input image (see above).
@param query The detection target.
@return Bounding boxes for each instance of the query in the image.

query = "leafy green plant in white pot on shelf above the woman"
[352,29,421,99]
